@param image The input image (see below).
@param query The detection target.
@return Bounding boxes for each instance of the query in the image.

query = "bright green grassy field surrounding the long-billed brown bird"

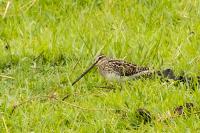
[0,0,200,133]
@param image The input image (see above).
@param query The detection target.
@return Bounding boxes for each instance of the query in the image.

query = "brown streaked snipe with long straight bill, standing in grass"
[72,54,154,85]
